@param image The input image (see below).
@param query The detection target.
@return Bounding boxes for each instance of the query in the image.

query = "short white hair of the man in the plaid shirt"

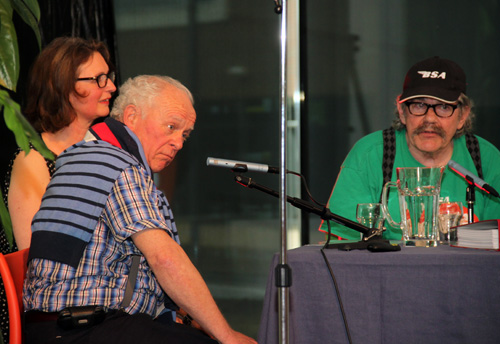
[110,75,194,122]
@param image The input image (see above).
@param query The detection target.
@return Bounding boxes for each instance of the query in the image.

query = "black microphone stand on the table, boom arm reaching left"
[233,176,401,252]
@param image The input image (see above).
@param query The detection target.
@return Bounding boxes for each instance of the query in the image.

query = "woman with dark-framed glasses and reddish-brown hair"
[2,37,116,251]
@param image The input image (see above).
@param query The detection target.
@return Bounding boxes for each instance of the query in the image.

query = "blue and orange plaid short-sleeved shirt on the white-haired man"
[23,166,179,316]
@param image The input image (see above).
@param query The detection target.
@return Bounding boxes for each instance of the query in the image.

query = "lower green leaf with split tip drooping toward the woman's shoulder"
[0,90,55,160]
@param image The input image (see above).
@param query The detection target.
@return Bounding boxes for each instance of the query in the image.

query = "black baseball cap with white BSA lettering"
[399,56,467,103]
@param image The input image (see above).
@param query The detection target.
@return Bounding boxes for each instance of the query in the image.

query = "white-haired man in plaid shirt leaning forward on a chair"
[24,76,255,344]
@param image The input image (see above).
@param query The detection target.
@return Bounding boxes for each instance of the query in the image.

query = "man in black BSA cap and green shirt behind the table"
[320,57,500,240]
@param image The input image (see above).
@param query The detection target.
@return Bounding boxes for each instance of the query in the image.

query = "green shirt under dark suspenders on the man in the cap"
[319,130,500,240]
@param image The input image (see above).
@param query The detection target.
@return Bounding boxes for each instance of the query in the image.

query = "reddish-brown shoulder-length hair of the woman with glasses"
[24,37,112,133]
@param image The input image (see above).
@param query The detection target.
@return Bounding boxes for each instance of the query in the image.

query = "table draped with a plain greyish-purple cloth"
[258,245,500,344]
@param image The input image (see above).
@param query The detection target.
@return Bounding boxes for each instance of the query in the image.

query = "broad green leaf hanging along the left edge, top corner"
[0,0,19,91]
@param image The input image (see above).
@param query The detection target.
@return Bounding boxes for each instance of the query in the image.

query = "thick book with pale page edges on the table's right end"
[451,219,500,250]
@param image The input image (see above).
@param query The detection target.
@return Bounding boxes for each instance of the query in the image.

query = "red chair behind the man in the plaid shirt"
[0,248,29,344]
